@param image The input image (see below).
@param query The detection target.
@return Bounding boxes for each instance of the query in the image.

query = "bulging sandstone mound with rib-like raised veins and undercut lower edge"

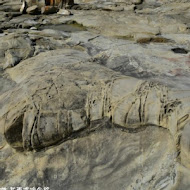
[1,51,190,162]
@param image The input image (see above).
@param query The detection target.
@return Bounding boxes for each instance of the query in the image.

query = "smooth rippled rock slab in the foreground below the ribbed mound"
[1,124,176,190]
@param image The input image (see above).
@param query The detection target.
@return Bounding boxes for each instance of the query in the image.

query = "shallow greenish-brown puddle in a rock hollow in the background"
[39,23,86,32]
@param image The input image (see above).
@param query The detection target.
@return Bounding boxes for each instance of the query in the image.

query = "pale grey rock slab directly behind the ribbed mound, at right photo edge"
[68,32,190,90]
